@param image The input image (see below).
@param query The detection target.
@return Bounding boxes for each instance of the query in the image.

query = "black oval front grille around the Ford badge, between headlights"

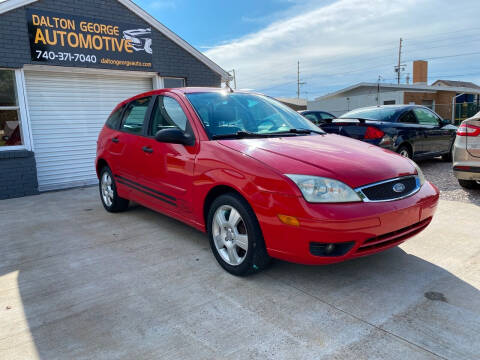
[360,176,418,201]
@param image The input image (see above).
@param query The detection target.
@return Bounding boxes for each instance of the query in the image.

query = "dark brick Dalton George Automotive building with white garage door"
[0,0,229,199]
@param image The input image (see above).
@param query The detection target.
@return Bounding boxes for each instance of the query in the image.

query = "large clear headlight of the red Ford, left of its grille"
[285,174,362,203]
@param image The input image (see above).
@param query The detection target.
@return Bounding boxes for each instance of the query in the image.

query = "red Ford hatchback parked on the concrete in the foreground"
[96,88,439,275]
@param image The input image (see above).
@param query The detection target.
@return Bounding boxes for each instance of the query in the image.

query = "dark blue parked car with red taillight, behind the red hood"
[321,105,457,161]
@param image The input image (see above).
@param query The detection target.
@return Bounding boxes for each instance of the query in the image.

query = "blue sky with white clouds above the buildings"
[135,0,480,99]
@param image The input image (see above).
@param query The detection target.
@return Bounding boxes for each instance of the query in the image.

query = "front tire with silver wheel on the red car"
[207,193,270,276]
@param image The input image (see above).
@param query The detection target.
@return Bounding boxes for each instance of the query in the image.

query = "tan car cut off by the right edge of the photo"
[453,112,480,189]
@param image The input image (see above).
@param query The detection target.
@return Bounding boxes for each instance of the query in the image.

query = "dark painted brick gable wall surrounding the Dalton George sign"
[0,0,221,86]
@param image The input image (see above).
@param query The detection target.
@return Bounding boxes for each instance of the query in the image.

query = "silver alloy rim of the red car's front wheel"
[212,205,248,266]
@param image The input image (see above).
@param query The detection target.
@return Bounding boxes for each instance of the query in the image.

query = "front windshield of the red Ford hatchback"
[186,91,323,138]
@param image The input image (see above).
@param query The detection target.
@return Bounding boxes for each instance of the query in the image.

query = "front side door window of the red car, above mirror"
[149,96,188,135]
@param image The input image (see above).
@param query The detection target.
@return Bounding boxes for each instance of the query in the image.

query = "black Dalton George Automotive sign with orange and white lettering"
[26,9,152,68]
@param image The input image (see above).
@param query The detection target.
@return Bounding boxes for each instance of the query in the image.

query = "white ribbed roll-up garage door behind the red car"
[25,71,152,191]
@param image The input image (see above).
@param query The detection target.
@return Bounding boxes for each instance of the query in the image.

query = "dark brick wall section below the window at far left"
[0,150,38,200]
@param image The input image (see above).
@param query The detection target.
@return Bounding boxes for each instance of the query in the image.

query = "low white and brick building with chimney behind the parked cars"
[307,60,480,120]
